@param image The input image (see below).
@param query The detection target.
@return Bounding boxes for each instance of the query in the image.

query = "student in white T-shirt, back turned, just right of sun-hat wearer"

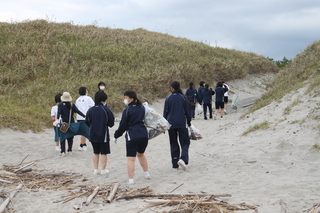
[76,87,94,151]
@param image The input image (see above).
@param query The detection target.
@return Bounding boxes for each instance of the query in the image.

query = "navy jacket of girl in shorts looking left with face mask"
[114,102,148,142]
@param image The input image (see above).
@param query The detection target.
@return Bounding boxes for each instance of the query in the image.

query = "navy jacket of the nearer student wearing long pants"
[163,91,191,129]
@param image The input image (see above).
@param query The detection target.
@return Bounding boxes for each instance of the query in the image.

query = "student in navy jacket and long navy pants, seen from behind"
[163,81,191,171]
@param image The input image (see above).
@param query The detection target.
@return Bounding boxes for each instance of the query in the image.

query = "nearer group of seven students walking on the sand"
[51,81,191,184]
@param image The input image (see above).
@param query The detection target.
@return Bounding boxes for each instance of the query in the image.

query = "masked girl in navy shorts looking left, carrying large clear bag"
[114,91,151,184]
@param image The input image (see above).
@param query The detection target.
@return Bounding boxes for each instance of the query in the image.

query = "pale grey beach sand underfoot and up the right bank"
[0,75,320,213]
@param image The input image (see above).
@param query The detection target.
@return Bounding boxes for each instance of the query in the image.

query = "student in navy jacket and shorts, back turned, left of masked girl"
[85,91,114,175]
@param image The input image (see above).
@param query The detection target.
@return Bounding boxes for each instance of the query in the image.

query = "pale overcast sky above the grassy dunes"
[0,0,320,60]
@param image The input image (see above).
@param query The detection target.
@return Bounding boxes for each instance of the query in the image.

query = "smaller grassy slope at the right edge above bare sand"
[247,41,320,113]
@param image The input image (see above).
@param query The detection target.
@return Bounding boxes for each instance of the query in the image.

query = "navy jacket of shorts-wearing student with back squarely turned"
[86,103,114,143]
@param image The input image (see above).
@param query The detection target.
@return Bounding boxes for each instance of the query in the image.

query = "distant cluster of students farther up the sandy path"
[185,81,235,120]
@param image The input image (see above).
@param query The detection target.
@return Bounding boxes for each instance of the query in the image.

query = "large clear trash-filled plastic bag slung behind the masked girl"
[143,102,171,139]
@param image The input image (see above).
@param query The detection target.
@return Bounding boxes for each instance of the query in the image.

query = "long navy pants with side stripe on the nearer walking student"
[169,128,190,168]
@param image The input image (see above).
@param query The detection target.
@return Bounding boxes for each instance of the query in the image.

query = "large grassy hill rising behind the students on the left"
[0,20,278,131]
